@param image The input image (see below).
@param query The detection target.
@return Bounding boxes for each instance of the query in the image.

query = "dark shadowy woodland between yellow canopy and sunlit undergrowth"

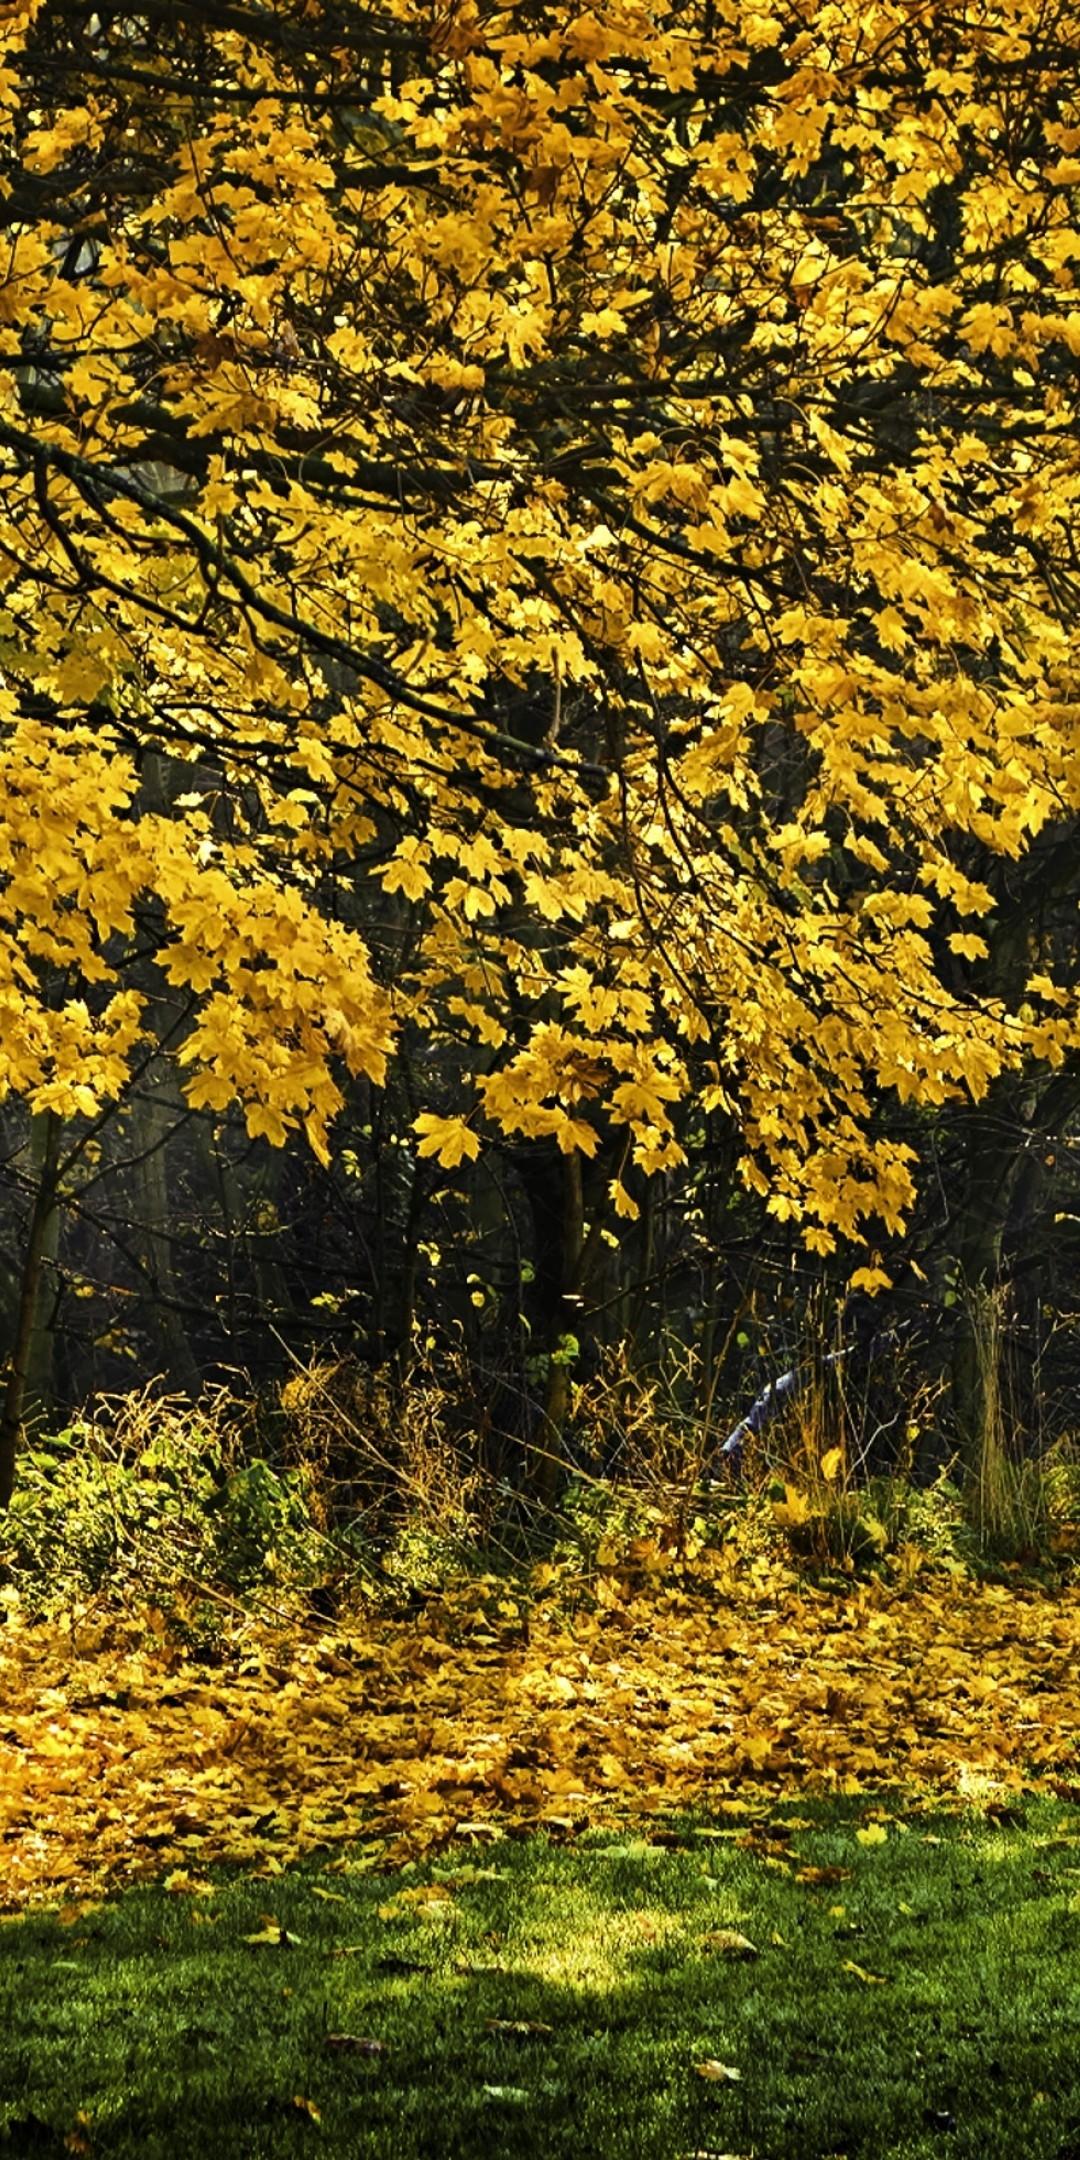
[0,972,1080,1482]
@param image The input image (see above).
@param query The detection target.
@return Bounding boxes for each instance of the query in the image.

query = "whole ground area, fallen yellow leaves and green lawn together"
[0,1555,1080,2160]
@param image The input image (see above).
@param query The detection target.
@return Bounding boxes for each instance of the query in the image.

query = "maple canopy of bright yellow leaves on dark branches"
[0,0,1080,1486]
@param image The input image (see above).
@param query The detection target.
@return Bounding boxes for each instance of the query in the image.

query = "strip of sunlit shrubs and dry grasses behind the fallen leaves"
[0,1363,1080,1646]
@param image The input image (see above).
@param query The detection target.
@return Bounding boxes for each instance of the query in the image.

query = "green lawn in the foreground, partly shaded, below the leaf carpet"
[0,1801,1080,2160]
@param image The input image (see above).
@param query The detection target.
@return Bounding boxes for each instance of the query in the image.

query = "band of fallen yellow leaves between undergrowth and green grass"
[0,1555,1080,1907]
